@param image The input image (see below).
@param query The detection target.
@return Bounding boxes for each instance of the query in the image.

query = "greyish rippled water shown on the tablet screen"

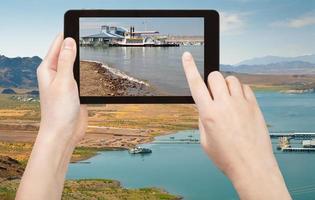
[80,46,204,96]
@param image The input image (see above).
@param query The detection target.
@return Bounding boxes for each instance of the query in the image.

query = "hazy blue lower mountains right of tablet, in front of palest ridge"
[220,61,315,74]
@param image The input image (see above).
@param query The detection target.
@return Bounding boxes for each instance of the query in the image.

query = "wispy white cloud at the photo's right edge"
[271,13,315,28]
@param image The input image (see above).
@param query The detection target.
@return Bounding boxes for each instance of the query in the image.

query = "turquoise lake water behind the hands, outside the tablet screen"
[67,92,315,200]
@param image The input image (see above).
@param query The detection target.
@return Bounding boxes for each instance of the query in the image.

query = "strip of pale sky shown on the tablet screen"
[79,17,204,36]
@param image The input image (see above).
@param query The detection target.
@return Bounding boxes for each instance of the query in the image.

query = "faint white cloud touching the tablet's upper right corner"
[220,12,245,34]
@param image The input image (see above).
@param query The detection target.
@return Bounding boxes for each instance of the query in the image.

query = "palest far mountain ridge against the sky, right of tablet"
[236,54,315,65]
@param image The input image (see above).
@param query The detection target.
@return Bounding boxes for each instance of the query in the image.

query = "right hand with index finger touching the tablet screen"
[183,52,290,199]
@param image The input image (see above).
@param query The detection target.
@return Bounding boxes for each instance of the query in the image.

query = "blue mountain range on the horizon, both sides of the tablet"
[0,54,315,88]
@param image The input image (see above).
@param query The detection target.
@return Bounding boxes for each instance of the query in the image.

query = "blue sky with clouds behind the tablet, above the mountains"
[0,0,315,64]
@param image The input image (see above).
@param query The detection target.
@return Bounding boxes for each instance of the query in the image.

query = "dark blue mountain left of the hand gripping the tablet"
[0,55,42,88]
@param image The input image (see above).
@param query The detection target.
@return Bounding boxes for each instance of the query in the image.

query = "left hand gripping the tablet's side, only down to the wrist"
[37,34,87,145]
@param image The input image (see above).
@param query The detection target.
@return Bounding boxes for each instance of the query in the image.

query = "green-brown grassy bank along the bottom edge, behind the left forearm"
[0,179,180,200]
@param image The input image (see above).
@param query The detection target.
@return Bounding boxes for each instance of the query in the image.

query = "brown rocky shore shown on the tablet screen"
[80,61,155,96]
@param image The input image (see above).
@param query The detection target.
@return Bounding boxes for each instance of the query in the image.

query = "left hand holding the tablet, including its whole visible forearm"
[16,34,87,200]
